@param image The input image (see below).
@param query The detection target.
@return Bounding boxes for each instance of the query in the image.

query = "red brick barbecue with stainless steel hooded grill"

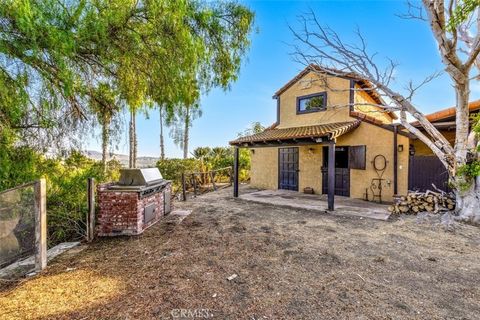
[97,168,172,236]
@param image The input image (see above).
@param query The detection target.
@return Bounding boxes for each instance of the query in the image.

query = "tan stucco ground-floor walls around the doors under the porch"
[251,122,409,201]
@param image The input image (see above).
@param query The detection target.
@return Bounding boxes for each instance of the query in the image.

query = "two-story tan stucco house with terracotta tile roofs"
[230,65,410,201]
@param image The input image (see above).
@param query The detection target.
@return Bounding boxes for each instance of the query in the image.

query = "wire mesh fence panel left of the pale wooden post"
[0,184,36,268]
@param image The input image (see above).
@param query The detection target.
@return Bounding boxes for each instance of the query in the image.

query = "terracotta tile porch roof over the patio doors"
[230,120,361,145]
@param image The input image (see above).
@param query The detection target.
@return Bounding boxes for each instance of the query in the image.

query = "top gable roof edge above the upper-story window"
[273,64,397,119]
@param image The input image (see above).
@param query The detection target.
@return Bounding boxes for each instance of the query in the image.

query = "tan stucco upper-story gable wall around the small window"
[278,72,352,128]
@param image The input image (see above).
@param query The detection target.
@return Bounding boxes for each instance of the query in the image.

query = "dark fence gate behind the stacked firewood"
[408,156,451,192]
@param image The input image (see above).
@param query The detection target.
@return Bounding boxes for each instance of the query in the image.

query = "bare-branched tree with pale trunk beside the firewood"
[291,0,480,223]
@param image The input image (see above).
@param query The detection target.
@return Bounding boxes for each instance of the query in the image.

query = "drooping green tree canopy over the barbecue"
[0,0,253,151]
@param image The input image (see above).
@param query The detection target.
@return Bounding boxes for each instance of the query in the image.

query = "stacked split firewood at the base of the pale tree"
[388,190,455,214]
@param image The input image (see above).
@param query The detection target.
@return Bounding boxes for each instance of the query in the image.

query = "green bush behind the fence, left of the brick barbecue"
[0,147,120,247]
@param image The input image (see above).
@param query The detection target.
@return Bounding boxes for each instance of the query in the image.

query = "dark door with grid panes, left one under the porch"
[278,147,298,191]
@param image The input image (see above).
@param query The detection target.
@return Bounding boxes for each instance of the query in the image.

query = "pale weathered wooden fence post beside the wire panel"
[34,178,47,271]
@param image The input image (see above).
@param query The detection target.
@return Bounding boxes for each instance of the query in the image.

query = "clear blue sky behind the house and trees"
[87,0,480,158]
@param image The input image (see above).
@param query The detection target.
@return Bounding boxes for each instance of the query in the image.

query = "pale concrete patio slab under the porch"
[239,190,390,220]
